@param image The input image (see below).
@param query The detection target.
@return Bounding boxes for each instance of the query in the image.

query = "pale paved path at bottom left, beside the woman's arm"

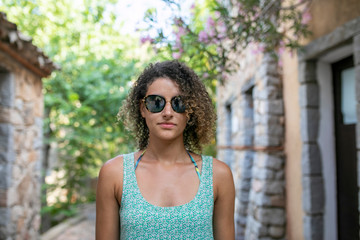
[41,204,95,240]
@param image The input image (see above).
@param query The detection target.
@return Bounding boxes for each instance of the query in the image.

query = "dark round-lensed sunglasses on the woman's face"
[143,95,186,113]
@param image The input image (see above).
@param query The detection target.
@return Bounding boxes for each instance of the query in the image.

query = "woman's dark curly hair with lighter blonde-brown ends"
[118,60,216,152]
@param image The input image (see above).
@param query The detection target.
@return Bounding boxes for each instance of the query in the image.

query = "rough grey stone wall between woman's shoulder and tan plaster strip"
[217,47,286,239]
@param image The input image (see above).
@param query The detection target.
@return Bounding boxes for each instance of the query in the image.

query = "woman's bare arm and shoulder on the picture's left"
[96,157,123,240]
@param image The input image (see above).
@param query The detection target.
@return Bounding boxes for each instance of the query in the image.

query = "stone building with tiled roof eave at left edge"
[0,12,55,240]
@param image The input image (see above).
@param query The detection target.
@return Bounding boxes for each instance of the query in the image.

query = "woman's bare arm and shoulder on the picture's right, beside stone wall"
[213,159,235,240]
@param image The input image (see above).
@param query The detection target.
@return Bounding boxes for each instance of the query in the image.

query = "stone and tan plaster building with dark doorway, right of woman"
[217,0,360,240]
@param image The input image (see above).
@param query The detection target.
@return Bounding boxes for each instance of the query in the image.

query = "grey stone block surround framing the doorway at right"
[299,18,360,239]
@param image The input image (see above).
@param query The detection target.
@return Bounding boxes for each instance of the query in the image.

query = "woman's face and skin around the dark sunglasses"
[140,78,187,142]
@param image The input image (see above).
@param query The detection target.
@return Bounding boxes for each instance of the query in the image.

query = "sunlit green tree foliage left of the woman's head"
[0,0,153,223]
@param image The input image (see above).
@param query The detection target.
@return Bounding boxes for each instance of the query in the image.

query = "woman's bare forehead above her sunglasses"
[146,78,180,97]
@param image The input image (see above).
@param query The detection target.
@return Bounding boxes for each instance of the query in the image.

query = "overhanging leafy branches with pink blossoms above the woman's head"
[139,0,311,81]
